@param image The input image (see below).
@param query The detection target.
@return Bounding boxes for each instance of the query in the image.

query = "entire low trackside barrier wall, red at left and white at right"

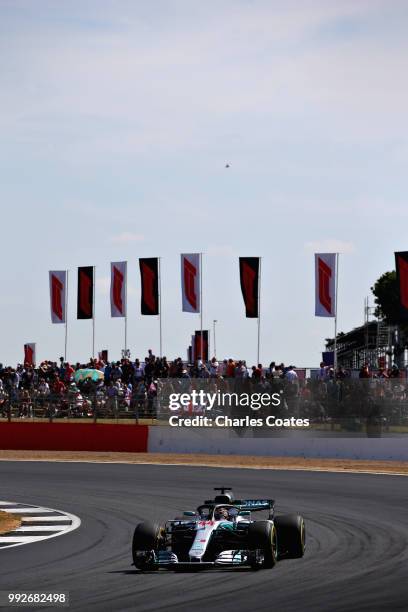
[0,421,408,461]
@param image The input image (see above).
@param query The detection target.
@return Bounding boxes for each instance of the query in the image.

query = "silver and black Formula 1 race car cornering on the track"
[132,487,306,571]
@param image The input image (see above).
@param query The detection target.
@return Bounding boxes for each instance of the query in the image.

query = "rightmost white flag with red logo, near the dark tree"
[315,253,337,317]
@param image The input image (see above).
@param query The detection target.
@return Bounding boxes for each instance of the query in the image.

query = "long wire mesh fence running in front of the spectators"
[0,377,408,434]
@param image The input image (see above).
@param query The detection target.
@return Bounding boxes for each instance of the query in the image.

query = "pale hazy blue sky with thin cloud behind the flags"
[0,0,408,366]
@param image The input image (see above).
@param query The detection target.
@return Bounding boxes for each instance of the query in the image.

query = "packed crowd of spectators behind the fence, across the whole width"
[0,350,408,428]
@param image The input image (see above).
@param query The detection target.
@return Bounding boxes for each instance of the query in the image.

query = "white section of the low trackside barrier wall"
[148,427,408,461]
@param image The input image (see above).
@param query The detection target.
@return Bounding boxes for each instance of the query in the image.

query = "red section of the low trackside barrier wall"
[0,422,149,453]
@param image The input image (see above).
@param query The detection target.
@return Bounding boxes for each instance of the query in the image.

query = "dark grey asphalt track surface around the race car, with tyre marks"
[0,462,408,612]
